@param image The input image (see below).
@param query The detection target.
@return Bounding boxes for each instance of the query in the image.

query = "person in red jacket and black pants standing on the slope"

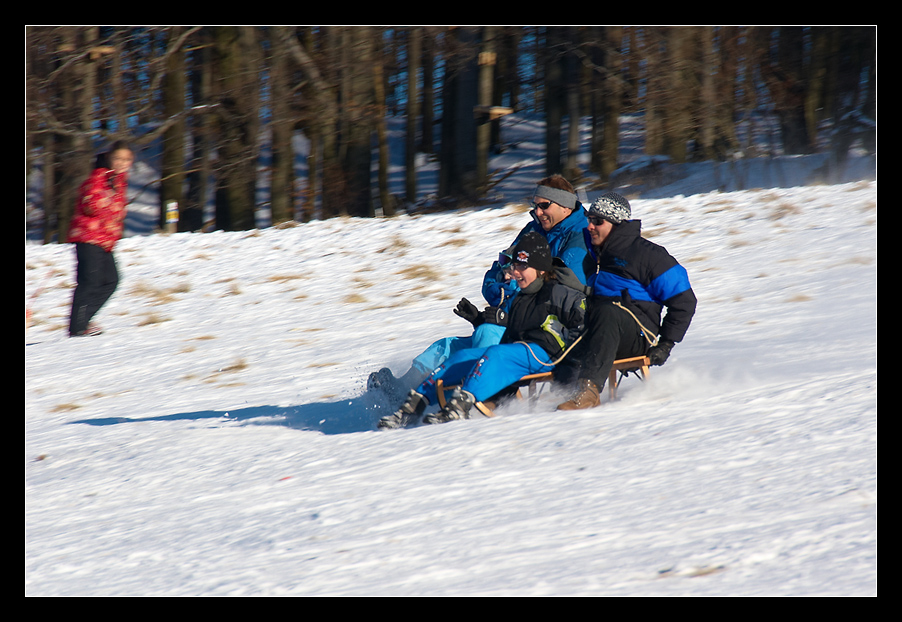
[69,141,135,337]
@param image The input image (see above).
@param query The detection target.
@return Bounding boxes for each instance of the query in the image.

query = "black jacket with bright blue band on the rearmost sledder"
[584,220,698,343]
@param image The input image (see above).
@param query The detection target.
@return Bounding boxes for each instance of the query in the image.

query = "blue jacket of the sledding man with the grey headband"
[482,203,589,312]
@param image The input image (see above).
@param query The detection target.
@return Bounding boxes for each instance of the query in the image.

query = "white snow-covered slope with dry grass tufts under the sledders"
[25,118,877,596]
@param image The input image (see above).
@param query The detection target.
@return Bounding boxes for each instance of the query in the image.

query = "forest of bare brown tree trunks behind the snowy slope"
[25,26,877,243]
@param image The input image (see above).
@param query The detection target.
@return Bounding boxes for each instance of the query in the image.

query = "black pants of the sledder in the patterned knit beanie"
[573,299,654,389]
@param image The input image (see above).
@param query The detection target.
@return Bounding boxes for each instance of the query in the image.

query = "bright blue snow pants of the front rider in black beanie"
[417,343,554,404]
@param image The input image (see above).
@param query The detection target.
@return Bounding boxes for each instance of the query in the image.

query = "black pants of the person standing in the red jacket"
[69,242,119,335]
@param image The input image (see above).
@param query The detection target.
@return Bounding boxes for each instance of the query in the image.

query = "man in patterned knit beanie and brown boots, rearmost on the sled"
[558,192,697,410]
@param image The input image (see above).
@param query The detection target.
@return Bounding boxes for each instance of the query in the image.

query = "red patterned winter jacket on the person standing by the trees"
[69,168,128,252]
